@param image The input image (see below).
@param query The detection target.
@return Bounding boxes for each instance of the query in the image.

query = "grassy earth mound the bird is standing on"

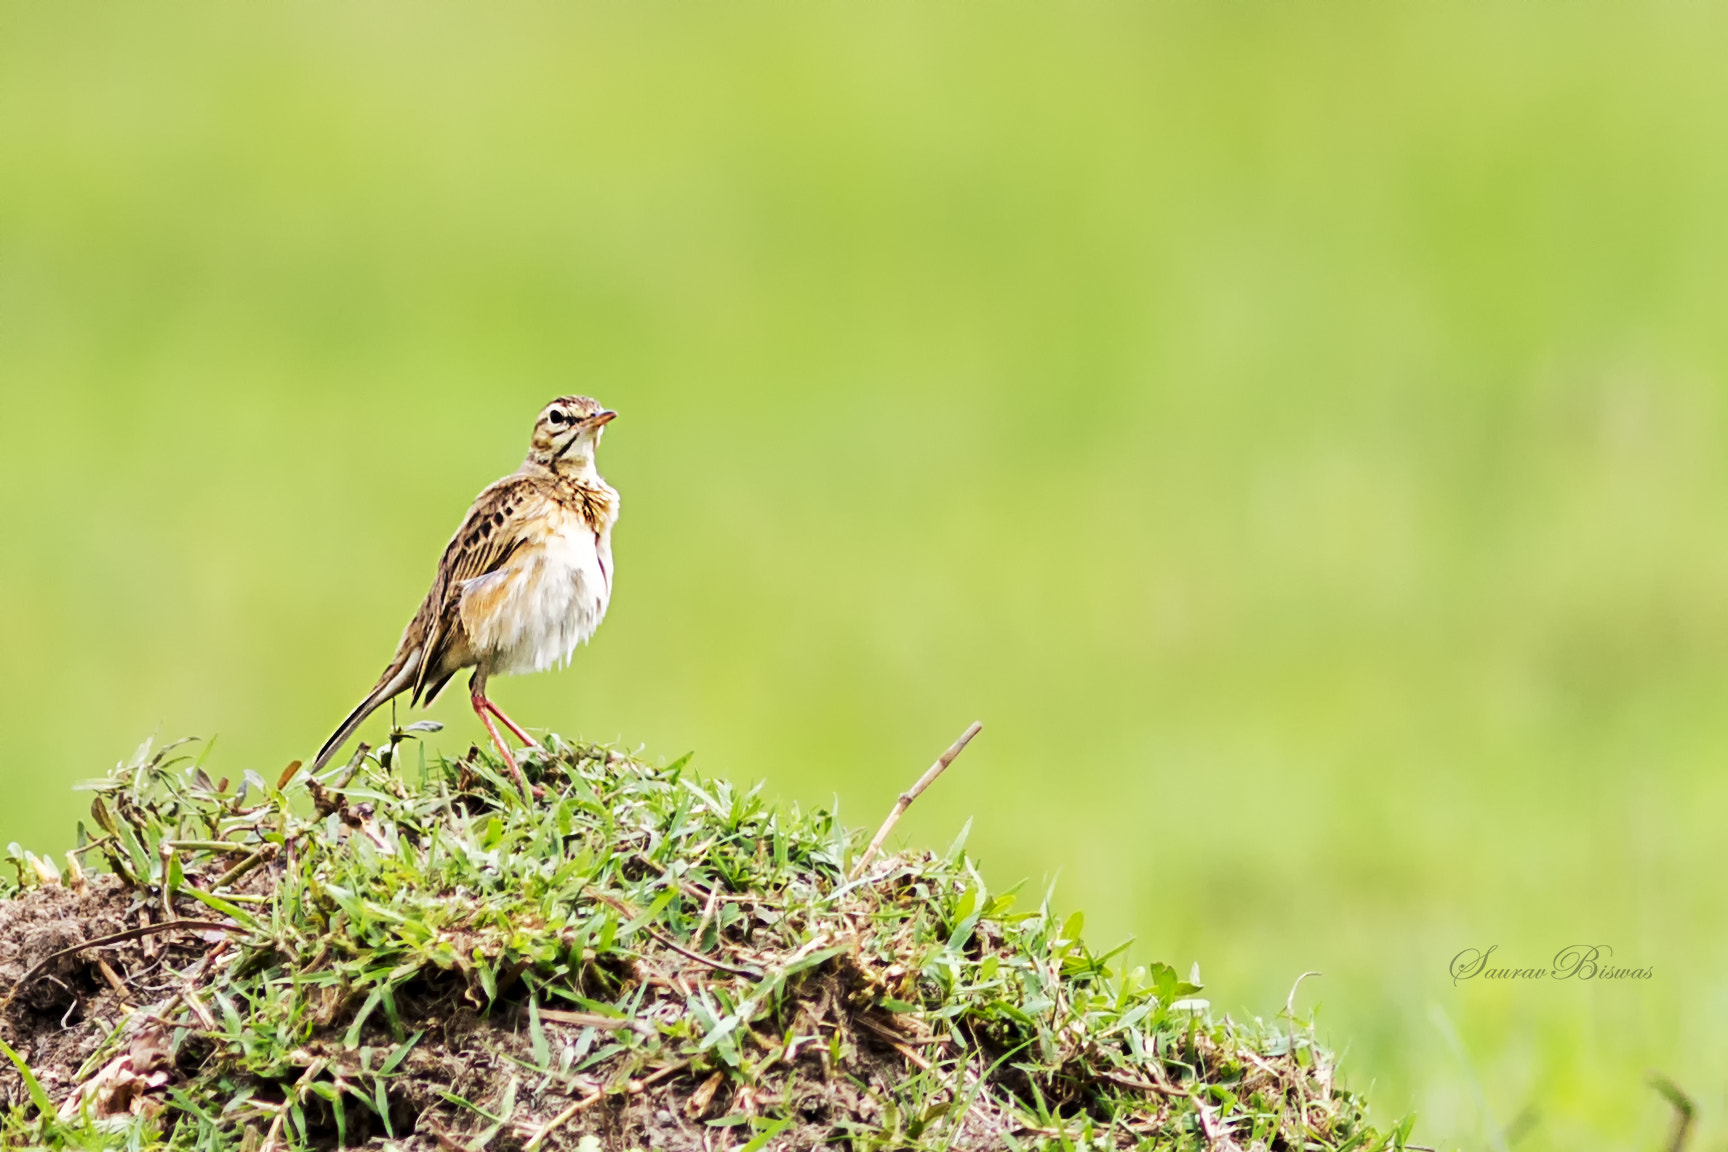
[0,725,1408,1152]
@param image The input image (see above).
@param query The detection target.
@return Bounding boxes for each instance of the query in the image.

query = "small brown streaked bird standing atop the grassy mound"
[313,396,619,796]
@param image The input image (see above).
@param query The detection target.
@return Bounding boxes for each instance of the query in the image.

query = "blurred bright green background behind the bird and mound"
[0,0,1728,1149]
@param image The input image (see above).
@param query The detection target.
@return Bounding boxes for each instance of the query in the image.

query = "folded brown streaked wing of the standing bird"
[415,477,546,703]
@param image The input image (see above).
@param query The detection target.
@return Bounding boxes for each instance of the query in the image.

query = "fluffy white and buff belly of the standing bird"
[463,522,612,675]
